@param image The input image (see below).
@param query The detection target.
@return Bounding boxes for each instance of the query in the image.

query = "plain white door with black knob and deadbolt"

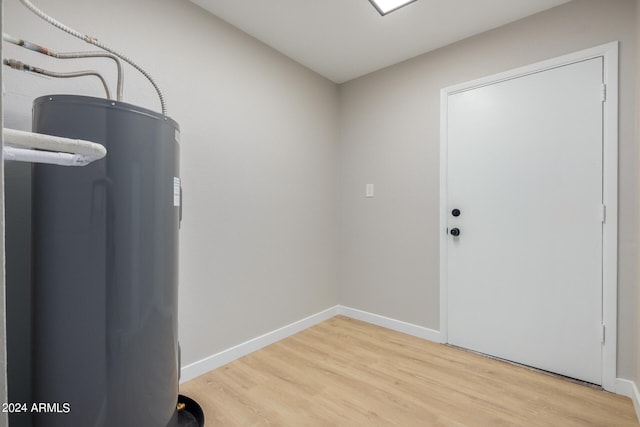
[446,57,603,384]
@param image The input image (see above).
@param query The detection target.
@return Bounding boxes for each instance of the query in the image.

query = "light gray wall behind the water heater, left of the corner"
[4,0,338,365]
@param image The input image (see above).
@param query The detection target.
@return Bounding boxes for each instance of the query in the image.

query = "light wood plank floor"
[180,316,639,427]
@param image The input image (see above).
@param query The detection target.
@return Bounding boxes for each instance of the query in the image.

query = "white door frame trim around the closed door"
[440,41,618,392]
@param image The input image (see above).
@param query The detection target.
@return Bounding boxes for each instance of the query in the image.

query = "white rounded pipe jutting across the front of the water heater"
[2,128,107,166]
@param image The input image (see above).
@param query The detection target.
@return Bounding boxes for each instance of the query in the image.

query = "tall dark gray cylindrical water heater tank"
[32,95,181,427]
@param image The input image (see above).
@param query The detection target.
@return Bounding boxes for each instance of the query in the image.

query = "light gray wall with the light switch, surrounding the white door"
[339,0,640,378]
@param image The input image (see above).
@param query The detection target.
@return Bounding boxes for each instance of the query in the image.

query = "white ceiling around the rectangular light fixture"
[191,0,570,83]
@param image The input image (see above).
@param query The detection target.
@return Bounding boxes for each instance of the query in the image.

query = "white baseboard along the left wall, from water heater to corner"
[180,306,339,383]
